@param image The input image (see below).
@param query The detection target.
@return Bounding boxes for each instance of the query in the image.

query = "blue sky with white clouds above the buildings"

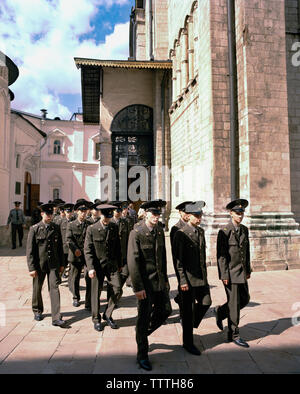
[0,0,135,120]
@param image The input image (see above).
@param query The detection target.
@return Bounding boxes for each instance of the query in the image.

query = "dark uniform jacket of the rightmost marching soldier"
[217,221,251,283]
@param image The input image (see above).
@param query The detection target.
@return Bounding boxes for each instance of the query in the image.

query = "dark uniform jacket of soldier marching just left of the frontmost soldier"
[84,220,122,272]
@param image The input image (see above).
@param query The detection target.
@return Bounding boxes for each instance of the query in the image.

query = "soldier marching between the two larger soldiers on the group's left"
[66,201,91,310]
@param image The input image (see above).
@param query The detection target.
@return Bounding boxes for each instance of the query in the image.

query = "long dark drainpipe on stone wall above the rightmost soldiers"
[227,0,239,200]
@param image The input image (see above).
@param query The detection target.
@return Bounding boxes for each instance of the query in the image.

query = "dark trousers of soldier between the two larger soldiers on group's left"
[68,261,91,308]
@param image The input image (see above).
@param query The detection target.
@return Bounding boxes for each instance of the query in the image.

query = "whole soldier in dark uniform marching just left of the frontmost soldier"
[84,204,122,331]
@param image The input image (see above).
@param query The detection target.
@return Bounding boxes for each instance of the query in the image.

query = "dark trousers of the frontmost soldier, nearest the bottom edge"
[136,290,172,360]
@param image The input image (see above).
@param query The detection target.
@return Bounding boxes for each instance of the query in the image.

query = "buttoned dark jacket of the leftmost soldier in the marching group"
[26,221,64,272]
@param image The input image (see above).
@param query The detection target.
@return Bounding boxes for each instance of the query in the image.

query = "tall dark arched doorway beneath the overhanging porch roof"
[111,104,154,209]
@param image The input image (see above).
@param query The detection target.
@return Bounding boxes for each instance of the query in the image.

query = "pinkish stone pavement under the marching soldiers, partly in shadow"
[0,238,300,374]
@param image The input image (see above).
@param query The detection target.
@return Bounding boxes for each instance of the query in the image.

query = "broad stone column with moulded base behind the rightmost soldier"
[236,0,300,270]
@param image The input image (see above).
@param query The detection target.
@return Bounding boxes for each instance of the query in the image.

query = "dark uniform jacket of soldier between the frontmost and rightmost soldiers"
[173,224,208,287]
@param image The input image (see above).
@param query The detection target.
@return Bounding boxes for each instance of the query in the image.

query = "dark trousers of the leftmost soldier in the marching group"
[32,269,60,321]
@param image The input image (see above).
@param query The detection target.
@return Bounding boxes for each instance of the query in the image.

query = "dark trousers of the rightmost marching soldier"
[218,282,250,339]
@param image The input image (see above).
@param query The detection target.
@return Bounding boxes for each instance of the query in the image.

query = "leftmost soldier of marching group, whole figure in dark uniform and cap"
[26,204,65,327]
